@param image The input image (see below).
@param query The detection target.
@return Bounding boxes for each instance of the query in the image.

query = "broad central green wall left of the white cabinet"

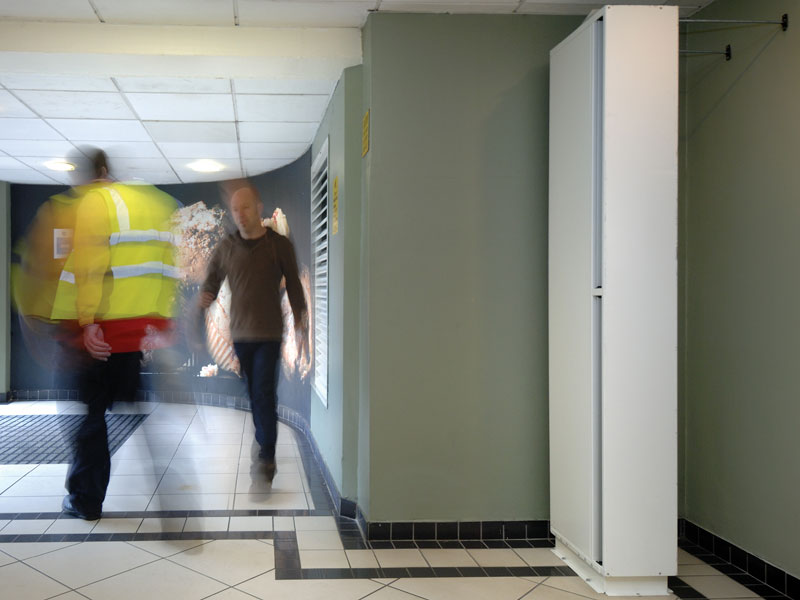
[359,14,580,521]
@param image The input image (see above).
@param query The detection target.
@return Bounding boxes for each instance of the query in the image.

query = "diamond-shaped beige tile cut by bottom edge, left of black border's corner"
[80,560,226,600]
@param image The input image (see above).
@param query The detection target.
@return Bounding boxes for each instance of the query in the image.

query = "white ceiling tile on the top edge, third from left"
[239,0,377,27]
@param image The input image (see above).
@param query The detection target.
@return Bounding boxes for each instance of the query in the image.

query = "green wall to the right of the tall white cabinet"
[682,0,800,576]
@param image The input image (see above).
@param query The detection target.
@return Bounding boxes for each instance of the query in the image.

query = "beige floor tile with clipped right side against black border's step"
[169,540,275,585]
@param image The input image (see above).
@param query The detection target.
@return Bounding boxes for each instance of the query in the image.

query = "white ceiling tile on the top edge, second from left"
[94,0,234,25]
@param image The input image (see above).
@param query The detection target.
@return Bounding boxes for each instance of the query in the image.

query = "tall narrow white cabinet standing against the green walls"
[549,6,678,595]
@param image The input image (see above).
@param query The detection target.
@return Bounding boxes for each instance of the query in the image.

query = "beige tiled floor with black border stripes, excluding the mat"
[0,401,780,600]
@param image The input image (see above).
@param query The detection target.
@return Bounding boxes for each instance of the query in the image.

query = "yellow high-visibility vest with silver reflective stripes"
[52,183,180,324]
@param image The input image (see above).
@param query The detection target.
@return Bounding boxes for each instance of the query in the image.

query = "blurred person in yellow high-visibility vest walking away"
[52,150,178,520]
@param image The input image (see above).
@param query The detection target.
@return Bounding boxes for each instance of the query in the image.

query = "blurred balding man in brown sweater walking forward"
[200,186,308,481]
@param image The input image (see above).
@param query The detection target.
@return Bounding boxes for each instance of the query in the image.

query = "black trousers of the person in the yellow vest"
[67,352,142,513]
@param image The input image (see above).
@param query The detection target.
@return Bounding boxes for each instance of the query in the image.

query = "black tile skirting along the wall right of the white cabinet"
[678,518,800,600]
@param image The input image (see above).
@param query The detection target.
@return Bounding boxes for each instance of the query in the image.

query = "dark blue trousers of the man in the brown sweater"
[233,341,281,460]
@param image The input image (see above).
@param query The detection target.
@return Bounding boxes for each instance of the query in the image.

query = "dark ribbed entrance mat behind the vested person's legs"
[0,414,147,465]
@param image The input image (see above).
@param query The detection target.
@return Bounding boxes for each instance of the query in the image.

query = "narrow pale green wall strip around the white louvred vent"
[311,66,361,500]
